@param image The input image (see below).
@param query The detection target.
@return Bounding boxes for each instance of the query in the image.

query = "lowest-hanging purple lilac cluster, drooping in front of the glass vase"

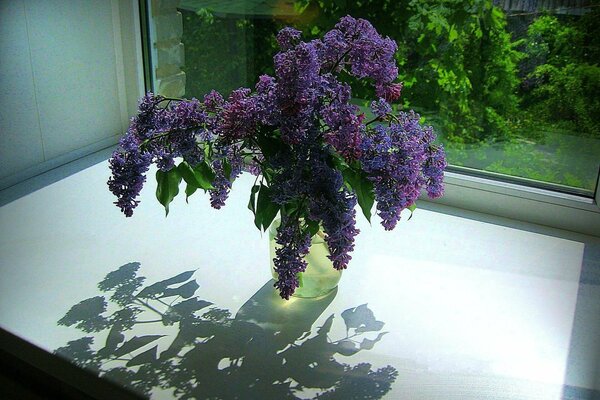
[273,218,310,300]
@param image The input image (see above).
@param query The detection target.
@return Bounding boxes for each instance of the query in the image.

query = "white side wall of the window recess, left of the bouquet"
[0,0,143,188]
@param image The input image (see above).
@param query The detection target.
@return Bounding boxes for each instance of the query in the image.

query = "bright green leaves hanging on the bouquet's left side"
[156,161,215,215]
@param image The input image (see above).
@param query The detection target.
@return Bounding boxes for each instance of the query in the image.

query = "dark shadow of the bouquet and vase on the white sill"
[55,263,398,399]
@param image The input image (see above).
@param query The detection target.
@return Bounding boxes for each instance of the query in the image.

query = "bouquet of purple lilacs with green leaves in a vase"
[108,16,446,299]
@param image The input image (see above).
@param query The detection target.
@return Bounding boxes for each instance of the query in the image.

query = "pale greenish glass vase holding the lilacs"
[269,219,342,298]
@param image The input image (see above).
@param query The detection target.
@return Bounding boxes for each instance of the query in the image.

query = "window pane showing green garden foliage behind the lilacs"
[148,0,600,197]
